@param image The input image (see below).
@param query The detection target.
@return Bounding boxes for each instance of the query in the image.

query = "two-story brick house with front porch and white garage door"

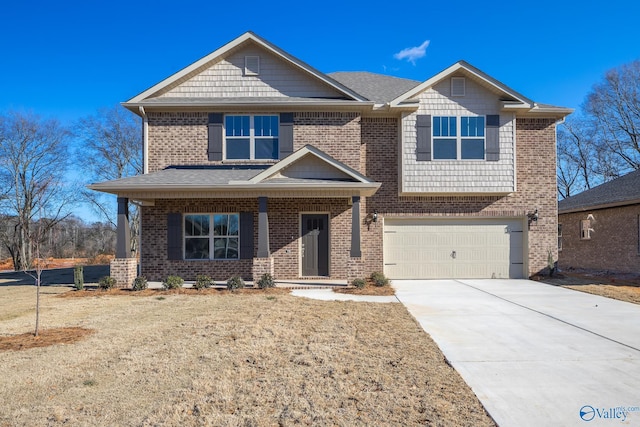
[90,32,571,283]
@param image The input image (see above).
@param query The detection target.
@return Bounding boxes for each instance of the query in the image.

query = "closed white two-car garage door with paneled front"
[384,219,524,279]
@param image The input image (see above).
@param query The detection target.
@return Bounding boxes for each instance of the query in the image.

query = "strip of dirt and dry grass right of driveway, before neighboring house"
[535,271,640,304]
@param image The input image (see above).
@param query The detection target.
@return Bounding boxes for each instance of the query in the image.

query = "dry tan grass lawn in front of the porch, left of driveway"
[0,286,494,426]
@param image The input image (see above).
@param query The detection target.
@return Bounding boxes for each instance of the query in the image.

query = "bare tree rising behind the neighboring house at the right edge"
[583,60,640,174]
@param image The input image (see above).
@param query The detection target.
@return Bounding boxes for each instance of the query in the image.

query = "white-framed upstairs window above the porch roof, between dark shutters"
[224,115,279,160]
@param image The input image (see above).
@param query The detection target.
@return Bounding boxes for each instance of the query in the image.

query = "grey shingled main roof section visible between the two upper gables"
[328,71,420,104]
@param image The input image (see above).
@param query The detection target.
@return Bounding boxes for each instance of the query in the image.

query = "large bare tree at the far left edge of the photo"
[0,112,73,271]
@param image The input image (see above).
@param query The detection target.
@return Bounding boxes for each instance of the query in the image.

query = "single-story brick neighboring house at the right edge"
[558,170,640,273]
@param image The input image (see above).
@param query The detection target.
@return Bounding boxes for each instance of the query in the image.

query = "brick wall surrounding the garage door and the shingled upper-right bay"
[362,118,557,275]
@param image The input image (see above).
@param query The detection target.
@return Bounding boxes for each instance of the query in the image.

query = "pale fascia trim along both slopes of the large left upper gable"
[124,32,367,107]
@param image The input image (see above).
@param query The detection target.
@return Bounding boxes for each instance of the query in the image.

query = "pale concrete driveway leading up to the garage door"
[393,279,640,426]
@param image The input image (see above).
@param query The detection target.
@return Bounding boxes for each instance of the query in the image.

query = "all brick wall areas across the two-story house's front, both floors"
[141,112,557,280]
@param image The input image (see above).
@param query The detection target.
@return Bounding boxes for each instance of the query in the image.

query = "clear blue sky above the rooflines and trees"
[0,0,640,221]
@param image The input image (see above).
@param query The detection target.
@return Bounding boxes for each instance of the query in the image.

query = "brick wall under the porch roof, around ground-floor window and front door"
[140,199,351,281]
